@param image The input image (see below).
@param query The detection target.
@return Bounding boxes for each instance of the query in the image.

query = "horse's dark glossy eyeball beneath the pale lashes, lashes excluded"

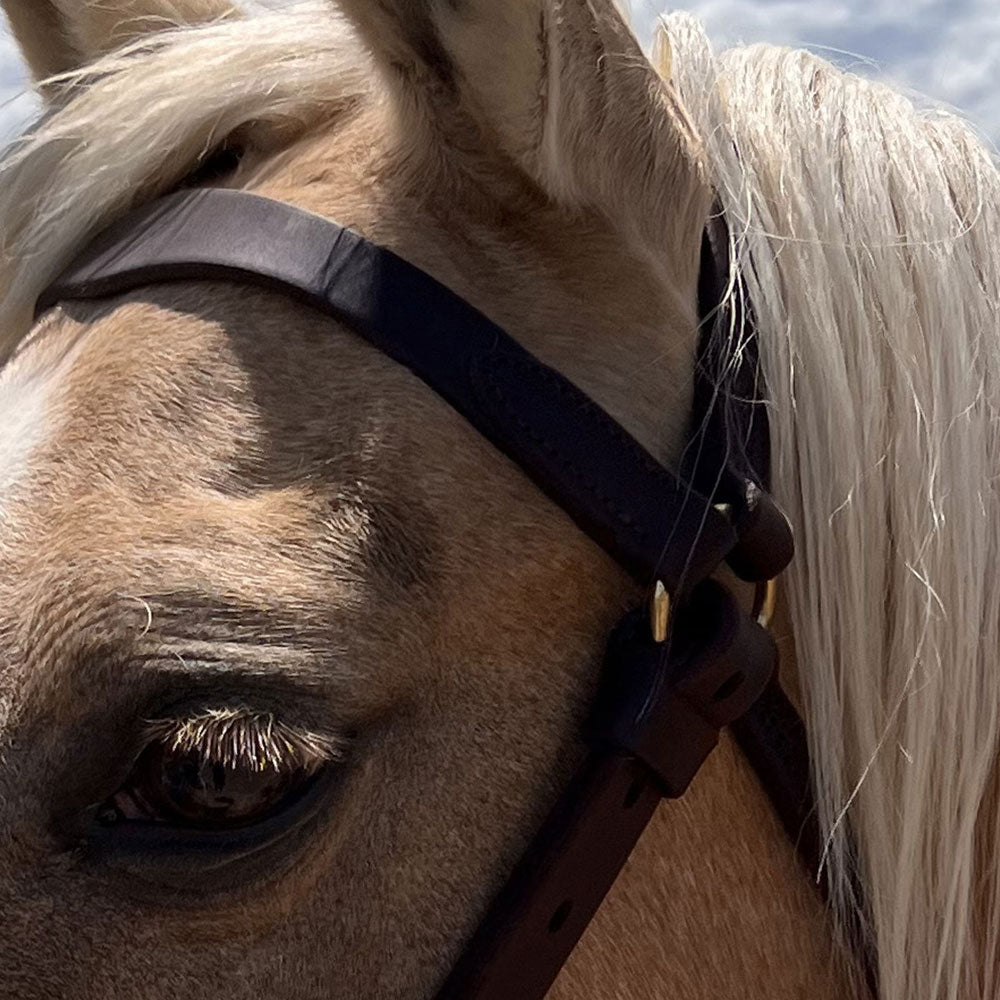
[98,744,314,830]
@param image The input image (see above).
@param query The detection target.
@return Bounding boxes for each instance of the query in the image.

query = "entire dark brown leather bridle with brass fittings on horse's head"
[38,189,818,1000]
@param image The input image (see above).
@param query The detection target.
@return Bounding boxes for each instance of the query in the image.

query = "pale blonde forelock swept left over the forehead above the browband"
[0,3,373,359]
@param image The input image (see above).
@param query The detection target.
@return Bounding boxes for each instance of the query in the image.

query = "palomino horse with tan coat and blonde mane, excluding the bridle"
[0,0,1000,1000]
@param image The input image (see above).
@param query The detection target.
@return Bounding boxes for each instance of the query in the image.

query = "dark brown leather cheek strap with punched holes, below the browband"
[437,581,777,1000]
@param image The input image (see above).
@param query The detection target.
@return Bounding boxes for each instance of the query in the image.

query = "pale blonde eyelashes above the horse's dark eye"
[142,707,347,774]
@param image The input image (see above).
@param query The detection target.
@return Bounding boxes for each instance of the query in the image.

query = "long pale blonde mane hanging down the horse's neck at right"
[660,15,1000,1000]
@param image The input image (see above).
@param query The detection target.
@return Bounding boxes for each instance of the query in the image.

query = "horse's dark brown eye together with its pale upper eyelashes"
[97,711,340,830]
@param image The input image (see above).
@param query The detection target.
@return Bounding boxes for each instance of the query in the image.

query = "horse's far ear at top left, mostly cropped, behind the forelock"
[0,0,235,80]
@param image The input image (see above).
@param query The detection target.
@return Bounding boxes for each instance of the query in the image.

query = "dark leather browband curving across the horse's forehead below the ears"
[38,189,791,596]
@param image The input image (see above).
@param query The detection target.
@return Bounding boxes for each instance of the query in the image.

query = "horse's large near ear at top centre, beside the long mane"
[338,0,709,246]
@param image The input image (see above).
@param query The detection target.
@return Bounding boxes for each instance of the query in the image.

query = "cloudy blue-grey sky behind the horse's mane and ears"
[0,0,1000,144]
